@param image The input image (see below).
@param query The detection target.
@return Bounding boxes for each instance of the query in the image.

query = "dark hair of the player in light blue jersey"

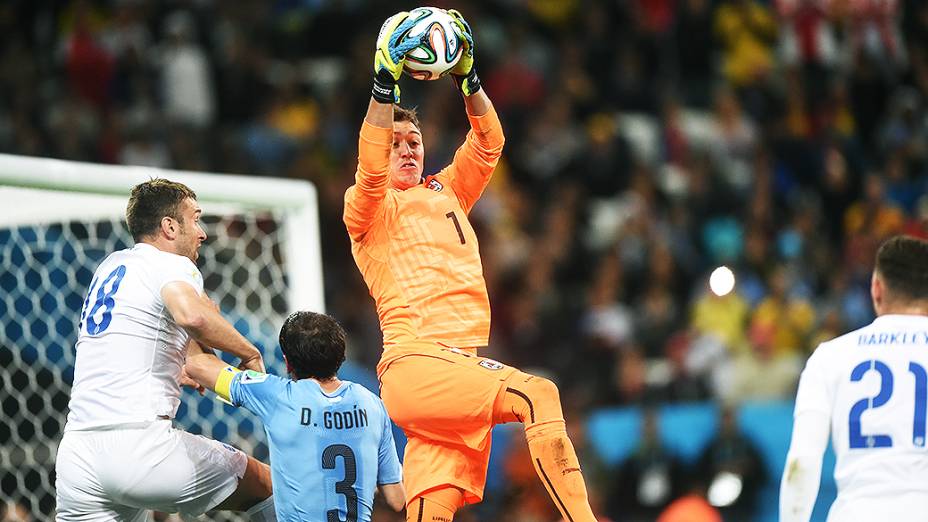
[280,312,345,379]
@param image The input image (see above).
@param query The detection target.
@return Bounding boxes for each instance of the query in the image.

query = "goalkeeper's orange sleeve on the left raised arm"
[342,121,393,241]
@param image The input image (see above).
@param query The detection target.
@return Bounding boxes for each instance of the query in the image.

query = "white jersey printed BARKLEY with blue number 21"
[796,315,928,521]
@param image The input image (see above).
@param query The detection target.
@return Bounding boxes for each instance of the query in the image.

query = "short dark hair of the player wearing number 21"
[876,236,928,301]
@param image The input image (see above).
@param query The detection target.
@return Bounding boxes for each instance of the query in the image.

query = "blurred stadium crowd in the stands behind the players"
[0,0,928,521]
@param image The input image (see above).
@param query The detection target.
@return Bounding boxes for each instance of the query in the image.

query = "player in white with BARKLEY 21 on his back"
[780,236,928,522]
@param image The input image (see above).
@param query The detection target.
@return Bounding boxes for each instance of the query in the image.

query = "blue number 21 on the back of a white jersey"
[848,360,928,449]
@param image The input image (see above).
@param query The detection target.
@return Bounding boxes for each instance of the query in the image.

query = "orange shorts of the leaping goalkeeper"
[378,345,516,504]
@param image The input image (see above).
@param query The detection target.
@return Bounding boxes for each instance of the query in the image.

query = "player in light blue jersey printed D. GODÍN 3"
[186,312,405,522]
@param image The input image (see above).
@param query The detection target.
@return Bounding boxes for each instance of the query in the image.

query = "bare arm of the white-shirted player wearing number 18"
[161,281,264,372]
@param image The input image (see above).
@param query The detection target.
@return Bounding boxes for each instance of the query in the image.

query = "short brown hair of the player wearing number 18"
[126,178,197,241]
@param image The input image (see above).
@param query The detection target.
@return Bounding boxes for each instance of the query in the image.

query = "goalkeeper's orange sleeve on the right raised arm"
[441,107,506,214]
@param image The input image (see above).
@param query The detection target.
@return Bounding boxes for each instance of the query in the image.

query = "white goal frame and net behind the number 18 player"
[0,154,324,520]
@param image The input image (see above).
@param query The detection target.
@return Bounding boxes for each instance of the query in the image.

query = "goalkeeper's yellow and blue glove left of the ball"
[371,11,422,103]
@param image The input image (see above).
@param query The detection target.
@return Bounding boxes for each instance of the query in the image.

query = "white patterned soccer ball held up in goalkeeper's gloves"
[403,7,464,80]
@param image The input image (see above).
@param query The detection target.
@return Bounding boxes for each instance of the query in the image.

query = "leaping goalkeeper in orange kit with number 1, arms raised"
[344,10,595,522]
